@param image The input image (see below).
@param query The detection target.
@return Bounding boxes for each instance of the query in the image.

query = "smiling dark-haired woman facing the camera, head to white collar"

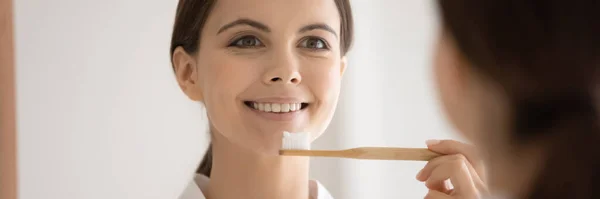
[171,0,352,199]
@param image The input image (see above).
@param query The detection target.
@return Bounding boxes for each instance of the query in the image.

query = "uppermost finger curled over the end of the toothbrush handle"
[427,140,485,177]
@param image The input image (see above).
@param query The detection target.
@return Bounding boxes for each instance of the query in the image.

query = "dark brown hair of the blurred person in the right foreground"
[438,0,600,199]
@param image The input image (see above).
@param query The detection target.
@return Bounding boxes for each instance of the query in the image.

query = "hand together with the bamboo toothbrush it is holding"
[279,132,488,199]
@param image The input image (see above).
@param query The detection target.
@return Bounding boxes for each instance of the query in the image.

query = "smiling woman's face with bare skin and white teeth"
[178,0,345,154]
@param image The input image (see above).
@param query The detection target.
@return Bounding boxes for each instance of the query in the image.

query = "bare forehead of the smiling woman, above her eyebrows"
[206,0,340,33]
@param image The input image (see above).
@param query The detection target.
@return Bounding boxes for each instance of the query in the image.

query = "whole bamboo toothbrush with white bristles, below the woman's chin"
[279,132,441,161]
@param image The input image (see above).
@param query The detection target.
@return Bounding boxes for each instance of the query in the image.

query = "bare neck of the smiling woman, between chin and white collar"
[207,133,309,199]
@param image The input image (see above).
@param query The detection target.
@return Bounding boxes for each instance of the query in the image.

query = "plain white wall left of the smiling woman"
[15,0,206,199]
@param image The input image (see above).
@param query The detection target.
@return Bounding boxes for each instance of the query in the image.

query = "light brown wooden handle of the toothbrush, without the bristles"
[279,147,441,161]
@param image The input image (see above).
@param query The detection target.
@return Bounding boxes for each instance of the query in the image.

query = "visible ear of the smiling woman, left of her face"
[172,46,203,101]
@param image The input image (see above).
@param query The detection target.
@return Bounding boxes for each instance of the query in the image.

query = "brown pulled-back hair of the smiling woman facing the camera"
[170,0,354,177]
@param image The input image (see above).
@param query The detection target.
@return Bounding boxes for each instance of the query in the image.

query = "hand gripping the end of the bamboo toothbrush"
[417,140,488,199]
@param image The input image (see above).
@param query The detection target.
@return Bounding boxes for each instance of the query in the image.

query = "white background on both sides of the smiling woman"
[15,0,460,199]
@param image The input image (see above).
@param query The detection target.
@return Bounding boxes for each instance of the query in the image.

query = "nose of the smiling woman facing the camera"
[263,53,302,85]
